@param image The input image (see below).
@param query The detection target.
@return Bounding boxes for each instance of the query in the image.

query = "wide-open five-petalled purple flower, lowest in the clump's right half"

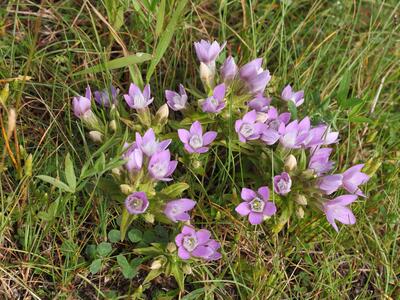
[235,186,276,225]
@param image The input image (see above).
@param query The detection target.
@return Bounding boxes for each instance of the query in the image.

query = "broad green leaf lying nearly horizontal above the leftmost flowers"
[74,52,152,76]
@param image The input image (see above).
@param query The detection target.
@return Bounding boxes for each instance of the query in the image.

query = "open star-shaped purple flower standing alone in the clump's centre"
[178,121,217,153]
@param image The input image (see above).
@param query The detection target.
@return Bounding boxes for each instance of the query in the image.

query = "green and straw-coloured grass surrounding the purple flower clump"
[0,0,400,299]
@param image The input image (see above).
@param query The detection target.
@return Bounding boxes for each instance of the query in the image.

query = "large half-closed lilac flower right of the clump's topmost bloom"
[239,58,271,94]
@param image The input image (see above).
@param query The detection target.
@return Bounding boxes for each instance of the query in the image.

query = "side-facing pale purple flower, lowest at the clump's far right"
[323,195,357,232]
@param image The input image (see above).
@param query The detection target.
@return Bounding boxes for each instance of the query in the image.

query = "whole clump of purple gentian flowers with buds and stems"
[72,40,369,274]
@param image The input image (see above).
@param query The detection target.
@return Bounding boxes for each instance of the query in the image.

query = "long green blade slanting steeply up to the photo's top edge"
[146,0,188,82]
